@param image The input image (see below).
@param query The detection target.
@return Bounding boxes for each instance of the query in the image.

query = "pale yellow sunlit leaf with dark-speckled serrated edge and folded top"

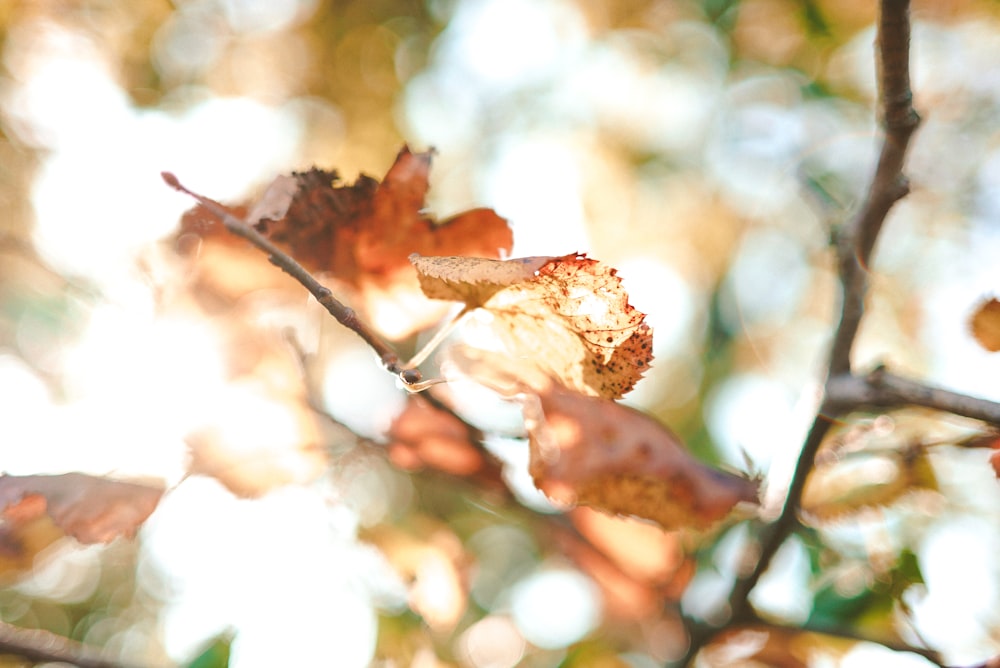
[410,253,653,399]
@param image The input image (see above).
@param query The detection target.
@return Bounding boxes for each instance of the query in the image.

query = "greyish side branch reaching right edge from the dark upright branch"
[826,367,1000,426]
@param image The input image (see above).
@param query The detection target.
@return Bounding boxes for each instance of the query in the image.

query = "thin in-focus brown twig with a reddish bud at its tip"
[160,172,421,385]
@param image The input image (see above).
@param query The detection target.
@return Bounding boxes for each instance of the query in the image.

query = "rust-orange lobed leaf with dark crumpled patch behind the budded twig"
[175,146,513,339]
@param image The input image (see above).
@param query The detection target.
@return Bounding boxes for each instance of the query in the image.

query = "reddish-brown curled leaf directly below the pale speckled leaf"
[525,384,757,529]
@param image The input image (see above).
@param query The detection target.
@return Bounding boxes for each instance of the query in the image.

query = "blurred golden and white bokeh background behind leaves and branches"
[0,0,1000,668]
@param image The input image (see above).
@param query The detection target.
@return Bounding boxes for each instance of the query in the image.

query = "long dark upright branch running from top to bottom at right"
[680,0,920,665]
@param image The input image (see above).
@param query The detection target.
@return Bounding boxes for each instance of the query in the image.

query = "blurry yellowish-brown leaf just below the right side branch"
[802,446,938,521]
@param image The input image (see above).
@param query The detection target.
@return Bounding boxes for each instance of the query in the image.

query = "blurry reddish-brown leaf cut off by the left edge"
[0,473,163,543]
